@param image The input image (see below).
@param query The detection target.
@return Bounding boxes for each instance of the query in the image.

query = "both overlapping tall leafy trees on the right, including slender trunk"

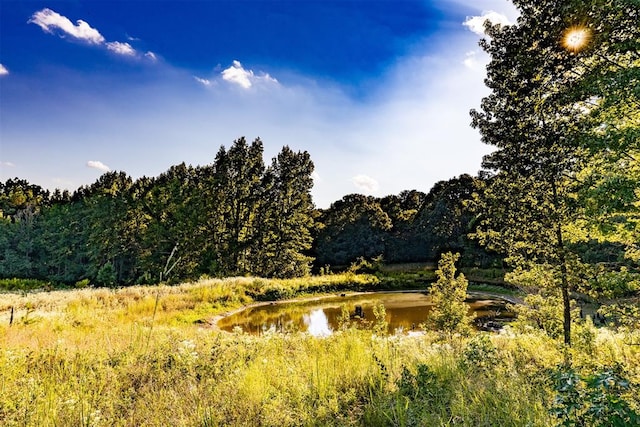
[472,0,640,344]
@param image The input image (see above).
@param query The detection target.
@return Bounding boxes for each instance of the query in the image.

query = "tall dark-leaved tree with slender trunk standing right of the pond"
[472,0,638,344]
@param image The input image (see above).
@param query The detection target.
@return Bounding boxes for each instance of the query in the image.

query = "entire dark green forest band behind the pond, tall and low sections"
[0,138,499,286]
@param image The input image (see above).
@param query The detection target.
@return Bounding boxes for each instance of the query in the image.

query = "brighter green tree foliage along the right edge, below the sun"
[560,0,640,262]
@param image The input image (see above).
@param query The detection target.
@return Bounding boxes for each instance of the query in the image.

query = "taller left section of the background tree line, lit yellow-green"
[0,138,314,285]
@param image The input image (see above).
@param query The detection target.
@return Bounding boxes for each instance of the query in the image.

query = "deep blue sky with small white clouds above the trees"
[0,0,517,207]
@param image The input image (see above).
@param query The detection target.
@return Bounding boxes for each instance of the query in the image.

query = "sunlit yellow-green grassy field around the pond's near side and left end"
[0,273,640,426]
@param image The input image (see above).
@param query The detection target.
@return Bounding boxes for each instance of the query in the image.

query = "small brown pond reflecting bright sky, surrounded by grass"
[218,292,513,336]
